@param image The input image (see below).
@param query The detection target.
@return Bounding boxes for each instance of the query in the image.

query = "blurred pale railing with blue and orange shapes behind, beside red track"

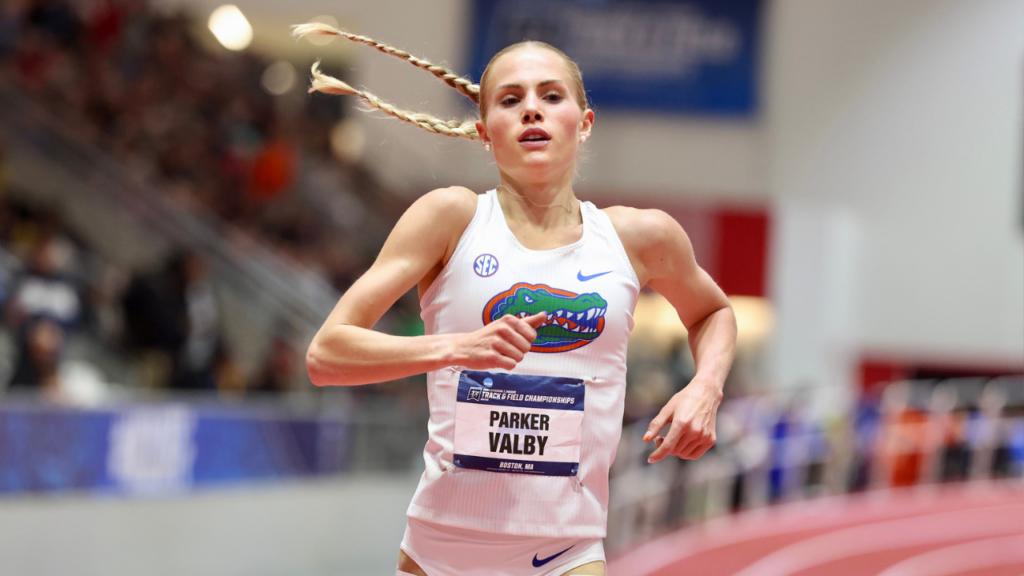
[606,377,1024,551]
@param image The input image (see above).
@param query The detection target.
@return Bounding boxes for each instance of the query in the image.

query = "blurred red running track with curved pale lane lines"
[608,481,1024,576]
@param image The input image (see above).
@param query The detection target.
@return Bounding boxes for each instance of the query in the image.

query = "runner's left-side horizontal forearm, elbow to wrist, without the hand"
[306,325,453,386]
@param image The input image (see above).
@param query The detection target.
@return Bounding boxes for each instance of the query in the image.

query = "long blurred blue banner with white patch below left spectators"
[0,403,350,495]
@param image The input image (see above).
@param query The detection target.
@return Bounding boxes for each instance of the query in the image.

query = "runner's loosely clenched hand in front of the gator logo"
[453,312,548,370]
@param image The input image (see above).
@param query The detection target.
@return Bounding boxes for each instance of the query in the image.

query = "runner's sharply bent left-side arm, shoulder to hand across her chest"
[306,188,544,385]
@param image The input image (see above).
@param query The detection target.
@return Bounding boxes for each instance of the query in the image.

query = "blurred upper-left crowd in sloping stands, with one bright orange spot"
[0,0,395,289]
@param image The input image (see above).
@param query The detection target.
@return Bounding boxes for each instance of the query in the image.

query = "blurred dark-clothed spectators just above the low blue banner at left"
[0,181,264,402]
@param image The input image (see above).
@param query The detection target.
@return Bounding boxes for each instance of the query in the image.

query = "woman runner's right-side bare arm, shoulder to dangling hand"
[607,207,736,462]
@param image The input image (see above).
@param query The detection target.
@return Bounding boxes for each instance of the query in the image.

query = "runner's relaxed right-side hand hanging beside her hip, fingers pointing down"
[643,378,722,462]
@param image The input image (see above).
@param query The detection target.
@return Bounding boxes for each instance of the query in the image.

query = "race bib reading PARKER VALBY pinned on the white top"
[455,370,587,476]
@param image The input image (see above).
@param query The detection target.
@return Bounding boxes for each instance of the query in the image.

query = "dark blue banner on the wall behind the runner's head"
[470,0,761,118]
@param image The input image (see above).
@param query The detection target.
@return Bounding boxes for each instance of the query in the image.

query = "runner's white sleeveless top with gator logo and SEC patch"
[408,190,640,538]
